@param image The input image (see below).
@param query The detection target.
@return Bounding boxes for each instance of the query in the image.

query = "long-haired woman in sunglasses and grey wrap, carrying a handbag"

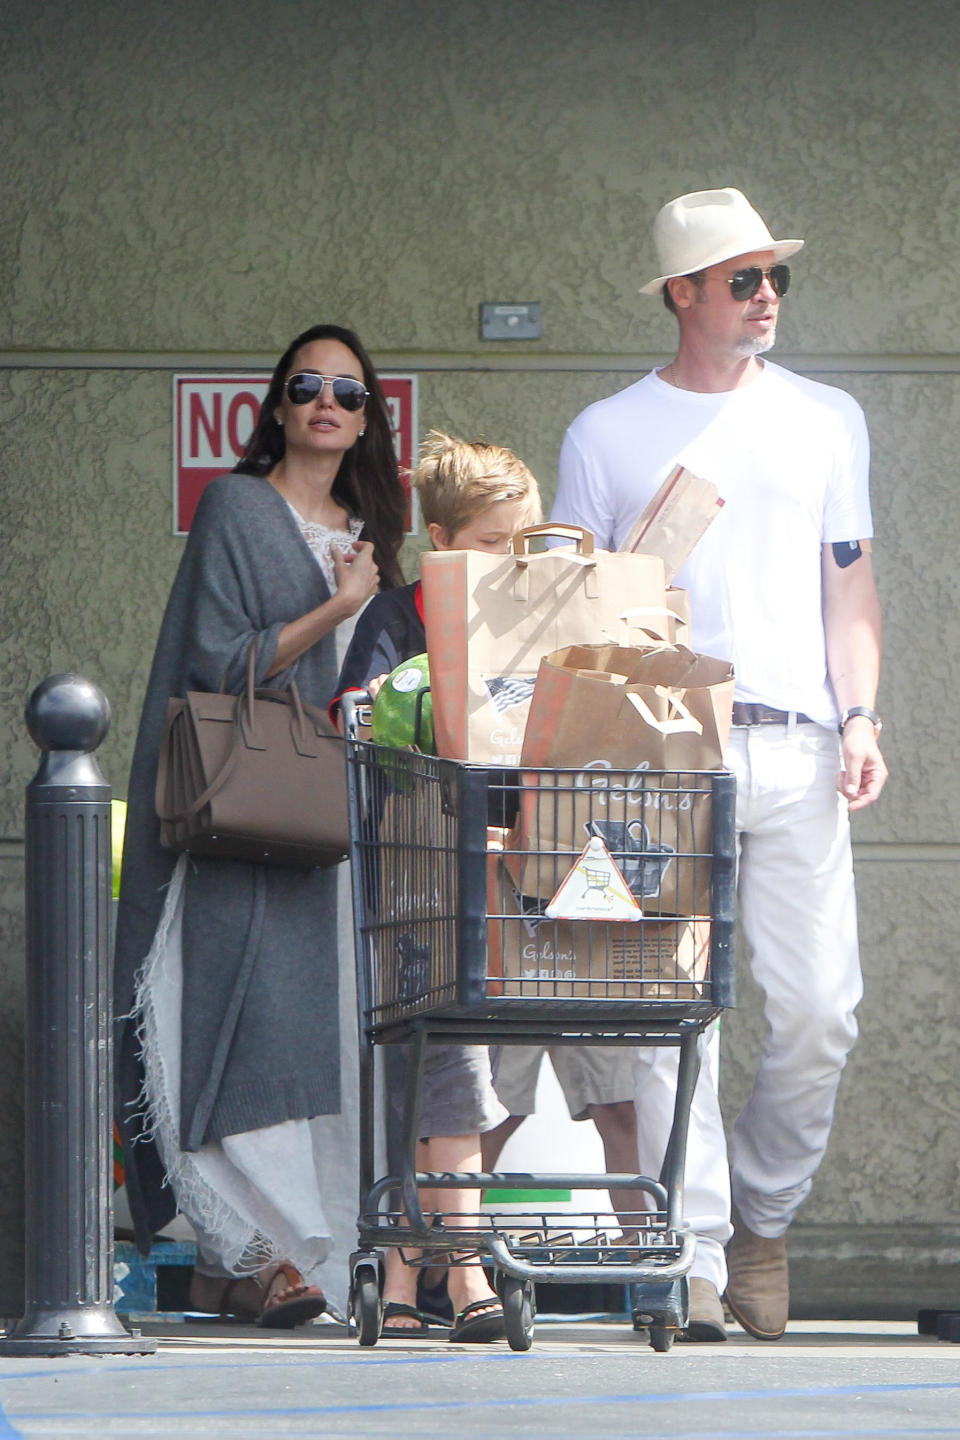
[115,325,404,1326]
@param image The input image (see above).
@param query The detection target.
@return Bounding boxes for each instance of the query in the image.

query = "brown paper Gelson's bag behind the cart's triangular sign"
[507,645,734,914]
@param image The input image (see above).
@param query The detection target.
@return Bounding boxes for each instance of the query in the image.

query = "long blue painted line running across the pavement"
[18,1381,960,1436]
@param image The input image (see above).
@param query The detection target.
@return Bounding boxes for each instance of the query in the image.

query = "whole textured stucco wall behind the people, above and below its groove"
[0,0,960,1312]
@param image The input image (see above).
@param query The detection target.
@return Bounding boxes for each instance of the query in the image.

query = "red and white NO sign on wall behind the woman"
[173,374,417,536]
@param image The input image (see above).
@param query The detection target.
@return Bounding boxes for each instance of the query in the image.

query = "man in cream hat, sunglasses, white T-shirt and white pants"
[554,189,887,1339]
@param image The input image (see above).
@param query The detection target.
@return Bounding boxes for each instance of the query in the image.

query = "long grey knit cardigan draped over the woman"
[114,474,349,1247]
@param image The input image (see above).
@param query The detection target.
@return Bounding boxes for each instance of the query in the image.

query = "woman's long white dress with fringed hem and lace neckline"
[137,505,363,1315]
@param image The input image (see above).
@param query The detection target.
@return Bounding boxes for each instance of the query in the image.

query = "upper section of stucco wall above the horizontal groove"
[0,0,960,353]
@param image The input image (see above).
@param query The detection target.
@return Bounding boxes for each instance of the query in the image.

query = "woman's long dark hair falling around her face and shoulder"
[235,325,407,590]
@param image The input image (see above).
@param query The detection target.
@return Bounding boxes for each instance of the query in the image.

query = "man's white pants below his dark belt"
[635,724,862,1293]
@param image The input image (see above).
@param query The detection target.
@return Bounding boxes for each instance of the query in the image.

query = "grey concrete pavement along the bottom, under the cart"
[0,1320,960,1440]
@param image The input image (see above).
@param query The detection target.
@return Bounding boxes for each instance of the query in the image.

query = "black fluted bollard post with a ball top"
[0,675,157,1355]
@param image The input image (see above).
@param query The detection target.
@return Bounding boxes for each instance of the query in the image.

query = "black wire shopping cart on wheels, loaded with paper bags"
[344,697,735,1351]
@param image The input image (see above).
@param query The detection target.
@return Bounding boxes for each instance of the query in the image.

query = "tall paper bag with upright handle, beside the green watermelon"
[420,526,667,765]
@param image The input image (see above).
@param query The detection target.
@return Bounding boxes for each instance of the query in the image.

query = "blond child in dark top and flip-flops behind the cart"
[337,431,541,1342]
